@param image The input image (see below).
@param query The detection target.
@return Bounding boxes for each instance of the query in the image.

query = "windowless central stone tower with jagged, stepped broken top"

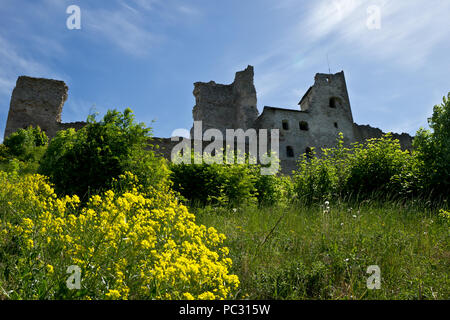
[191,66,258,136]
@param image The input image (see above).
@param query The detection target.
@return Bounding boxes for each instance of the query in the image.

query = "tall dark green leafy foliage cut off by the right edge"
[413,92,450,198]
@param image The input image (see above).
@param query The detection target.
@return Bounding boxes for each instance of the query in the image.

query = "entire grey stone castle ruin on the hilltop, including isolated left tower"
[4,66,412,174]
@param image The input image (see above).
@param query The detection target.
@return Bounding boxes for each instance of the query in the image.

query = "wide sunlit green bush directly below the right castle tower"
[293,133,417,203]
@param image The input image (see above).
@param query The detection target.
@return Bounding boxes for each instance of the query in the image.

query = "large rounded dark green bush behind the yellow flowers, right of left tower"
[40,109,168,199]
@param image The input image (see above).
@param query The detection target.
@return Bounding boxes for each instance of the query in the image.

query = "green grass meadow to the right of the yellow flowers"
[191,201,450,299]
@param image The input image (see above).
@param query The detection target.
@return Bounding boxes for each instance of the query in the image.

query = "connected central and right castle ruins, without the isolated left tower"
[191,66,412,173]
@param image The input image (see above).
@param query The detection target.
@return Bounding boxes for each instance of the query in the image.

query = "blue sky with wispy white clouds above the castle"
[0,0,450,141]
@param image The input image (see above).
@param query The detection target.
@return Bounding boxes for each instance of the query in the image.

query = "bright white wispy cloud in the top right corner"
[297,0,450,68]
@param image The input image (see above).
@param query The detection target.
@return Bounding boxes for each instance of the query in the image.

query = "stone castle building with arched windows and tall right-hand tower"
[255,72,355,173]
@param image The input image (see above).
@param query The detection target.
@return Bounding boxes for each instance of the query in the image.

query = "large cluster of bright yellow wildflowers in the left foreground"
[0,172,239,299]
